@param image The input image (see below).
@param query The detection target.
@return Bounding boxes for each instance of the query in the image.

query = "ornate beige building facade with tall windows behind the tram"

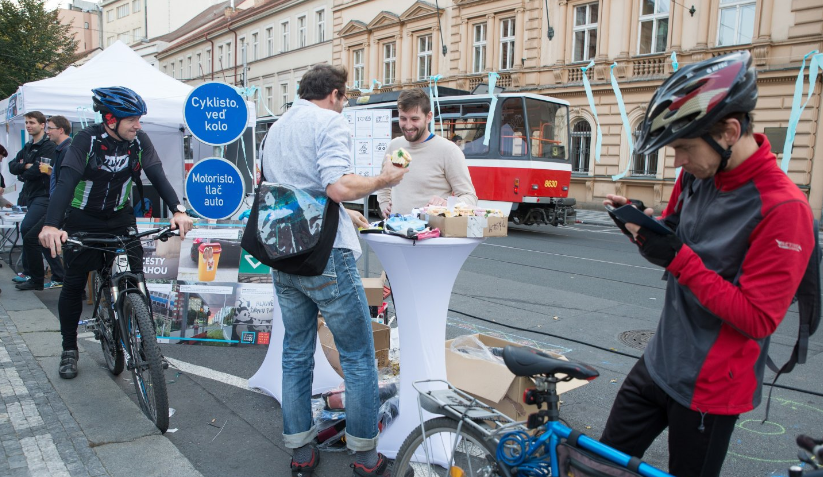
[332,0,823,215]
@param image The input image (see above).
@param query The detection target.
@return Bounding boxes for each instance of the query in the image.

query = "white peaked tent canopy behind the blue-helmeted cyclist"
[0,41,255,208]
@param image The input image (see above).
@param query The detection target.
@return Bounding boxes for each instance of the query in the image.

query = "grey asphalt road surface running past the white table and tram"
[39,224,823,477]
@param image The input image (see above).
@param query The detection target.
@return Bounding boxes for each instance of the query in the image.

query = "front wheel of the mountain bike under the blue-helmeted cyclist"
[123,293,169,432]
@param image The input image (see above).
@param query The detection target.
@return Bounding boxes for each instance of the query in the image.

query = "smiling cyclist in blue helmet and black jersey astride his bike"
[39,86,192,379]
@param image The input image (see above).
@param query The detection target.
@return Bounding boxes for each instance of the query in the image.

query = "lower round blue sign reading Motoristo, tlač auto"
[184,157,245,219]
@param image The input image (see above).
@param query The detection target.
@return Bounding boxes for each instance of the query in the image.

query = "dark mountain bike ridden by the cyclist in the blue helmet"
[65,227,177,433]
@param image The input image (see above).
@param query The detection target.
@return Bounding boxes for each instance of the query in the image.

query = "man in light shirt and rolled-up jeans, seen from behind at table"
[262,64,408,476]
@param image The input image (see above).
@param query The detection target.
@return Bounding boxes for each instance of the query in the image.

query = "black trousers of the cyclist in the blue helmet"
[57,207,143,350]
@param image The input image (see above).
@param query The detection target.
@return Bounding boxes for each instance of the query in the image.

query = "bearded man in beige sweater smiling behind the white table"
[377,89,477,217]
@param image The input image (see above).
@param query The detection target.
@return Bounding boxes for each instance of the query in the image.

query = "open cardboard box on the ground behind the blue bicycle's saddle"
[446,334,588,421]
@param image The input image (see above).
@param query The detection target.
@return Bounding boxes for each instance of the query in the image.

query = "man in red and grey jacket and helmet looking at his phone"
[601,51,816,477]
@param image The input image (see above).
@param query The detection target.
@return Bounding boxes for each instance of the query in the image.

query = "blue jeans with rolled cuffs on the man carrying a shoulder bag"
[272,248,380,451]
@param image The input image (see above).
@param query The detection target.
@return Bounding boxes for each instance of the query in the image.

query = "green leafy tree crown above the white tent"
[0,0,77,98]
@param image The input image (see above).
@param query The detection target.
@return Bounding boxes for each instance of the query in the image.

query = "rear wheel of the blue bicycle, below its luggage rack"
[392,417,500,477]
